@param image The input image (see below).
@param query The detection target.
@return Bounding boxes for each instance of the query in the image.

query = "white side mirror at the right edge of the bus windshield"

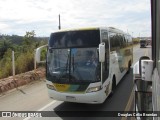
[99,43,105,62]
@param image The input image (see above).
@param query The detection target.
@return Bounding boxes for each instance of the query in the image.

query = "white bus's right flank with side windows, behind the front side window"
[109,31,133,84]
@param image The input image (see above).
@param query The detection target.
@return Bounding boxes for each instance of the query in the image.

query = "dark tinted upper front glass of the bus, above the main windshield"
[49,30,100,48]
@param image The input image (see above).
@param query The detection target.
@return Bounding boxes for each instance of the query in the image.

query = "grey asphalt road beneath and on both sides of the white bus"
[0,45,151,120]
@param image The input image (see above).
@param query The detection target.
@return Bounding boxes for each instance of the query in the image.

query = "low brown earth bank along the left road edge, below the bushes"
[0,68,45,94]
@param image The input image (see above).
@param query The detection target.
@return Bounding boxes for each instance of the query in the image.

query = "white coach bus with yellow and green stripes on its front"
[36,27,133,104]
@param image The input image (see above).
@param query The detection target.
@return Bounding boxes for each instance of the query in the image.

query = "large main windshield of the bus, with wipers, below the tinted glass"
[47,47,100,84]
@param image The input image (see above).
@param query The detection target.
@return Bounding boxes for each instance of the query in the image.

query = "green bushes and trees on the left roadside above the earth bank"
[0,31,48,78]
